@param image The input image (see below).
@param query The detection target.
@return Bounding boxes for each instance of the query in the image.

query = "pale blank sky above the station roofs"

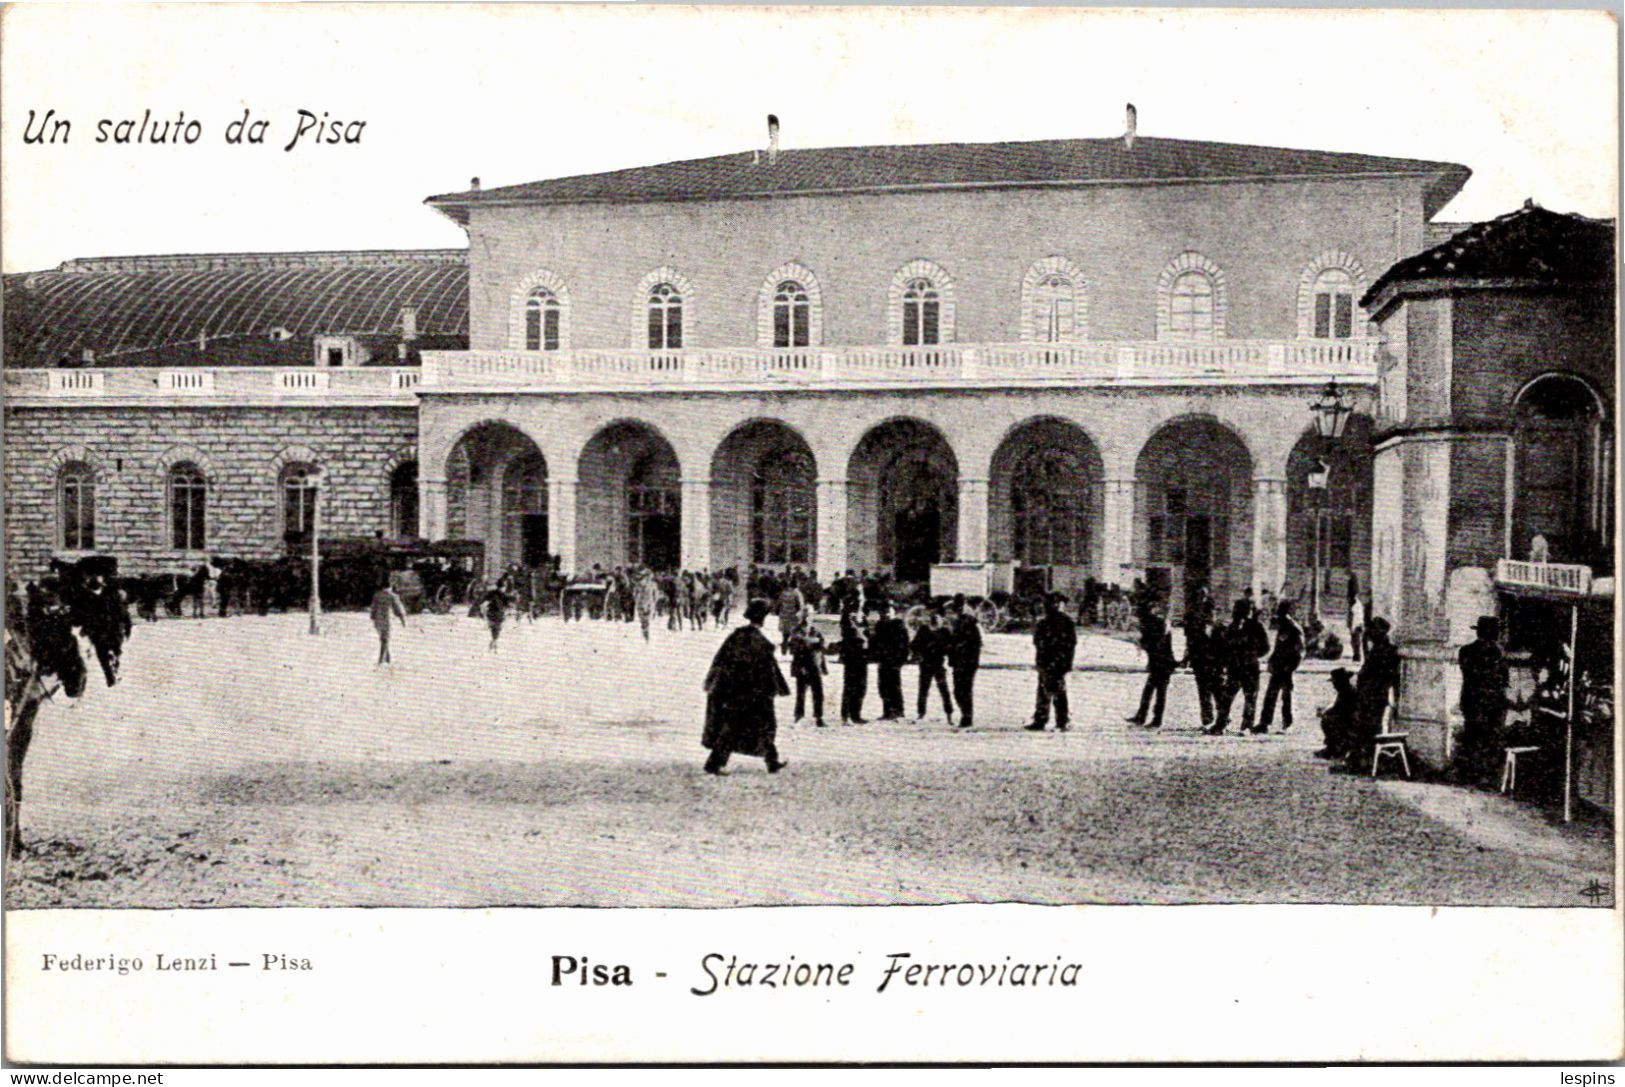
[0,5,1619,271]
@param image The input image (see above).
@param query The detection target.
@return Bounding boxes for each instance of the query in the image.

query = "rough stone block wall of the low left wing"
[5,406,418,578]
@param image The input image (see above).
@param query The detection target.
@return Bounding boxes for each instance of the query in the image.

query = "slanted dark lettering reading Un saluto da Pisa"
[23,109,367,151]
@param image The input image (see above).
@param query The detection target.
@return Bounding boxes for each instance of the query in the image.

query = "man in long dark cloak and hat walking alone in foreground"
[700,600,790,775]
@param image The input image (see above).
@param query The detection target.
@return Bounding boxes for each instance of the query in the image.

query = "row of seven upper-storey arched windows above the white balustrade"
[518,252,1365,351]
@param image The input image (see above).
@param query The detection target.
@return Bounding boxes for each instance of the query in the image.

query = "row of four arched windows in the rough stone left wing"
[57,460,418,551]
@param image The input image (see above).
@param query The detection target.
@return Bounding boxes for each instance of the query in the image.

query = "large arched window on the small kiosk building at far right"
[1511,374,1614,565]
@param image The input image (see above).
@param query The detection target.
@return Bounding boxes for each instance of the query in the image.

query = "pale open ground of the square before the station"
[7,614,1614,907]
